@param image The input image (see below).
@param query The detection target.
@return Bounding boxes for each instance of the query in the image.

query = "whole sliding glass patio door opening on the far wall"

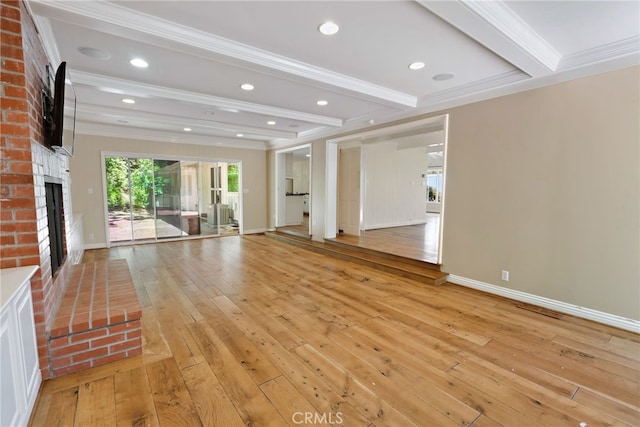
[103,154,242,245]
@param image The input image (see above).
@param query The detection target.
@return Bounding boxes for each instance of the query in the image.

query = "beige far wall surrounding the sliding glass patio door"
[69,135,267,247]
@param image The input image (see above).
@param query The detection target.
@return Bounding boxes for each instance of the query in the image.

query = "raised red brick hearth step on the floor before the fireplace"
[48,259,142,377]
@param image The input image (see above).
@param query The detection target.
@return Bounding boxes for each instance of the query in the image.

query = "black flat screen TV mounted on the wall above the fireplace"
[42,62,76,156]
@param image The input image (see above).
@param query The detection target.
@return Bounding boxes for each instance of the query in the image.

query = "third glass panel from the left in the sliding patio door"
[153,160,182,239]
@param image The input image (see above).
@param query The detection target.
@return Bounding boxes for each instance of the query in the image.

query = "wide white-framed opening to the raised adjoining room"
[324,115,448,264]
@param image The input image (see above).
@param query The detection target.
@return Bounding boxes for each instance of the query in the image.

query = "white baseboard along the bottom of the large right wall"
[447,274,640,334]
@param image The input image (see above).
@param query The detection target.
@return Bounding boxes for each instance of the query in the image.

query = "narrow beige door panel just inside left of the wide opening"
[338,147,360,236]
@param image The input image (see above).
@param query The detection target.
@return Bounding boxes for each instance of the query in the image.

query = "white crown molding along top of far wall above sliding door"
[75,122,266,150]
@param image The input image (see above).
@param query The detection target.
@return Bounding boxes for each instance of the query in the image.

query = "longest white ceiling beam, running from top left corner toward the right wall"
[30,0,417,107]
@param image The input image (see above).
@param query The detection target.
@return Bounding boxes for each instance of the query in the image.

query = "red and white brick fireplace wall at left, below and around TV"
[0,0,82,379]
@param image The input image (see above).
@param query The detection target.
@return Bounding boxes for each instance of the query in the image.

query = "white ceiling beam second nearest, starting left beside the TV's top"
[70,70,343,127]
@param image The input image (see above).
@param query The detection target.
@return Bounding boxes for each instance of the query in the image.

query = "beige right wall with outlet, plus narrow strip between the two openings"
[270,67,640,319]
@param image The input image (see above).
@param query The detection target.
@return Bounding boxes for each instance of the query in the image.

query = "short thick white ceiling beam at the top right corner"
[418,0,562,76]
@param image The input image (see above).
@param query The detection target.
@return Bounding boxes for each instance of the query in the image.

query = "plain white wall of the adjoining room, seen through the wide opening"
[362,141,427,230]
